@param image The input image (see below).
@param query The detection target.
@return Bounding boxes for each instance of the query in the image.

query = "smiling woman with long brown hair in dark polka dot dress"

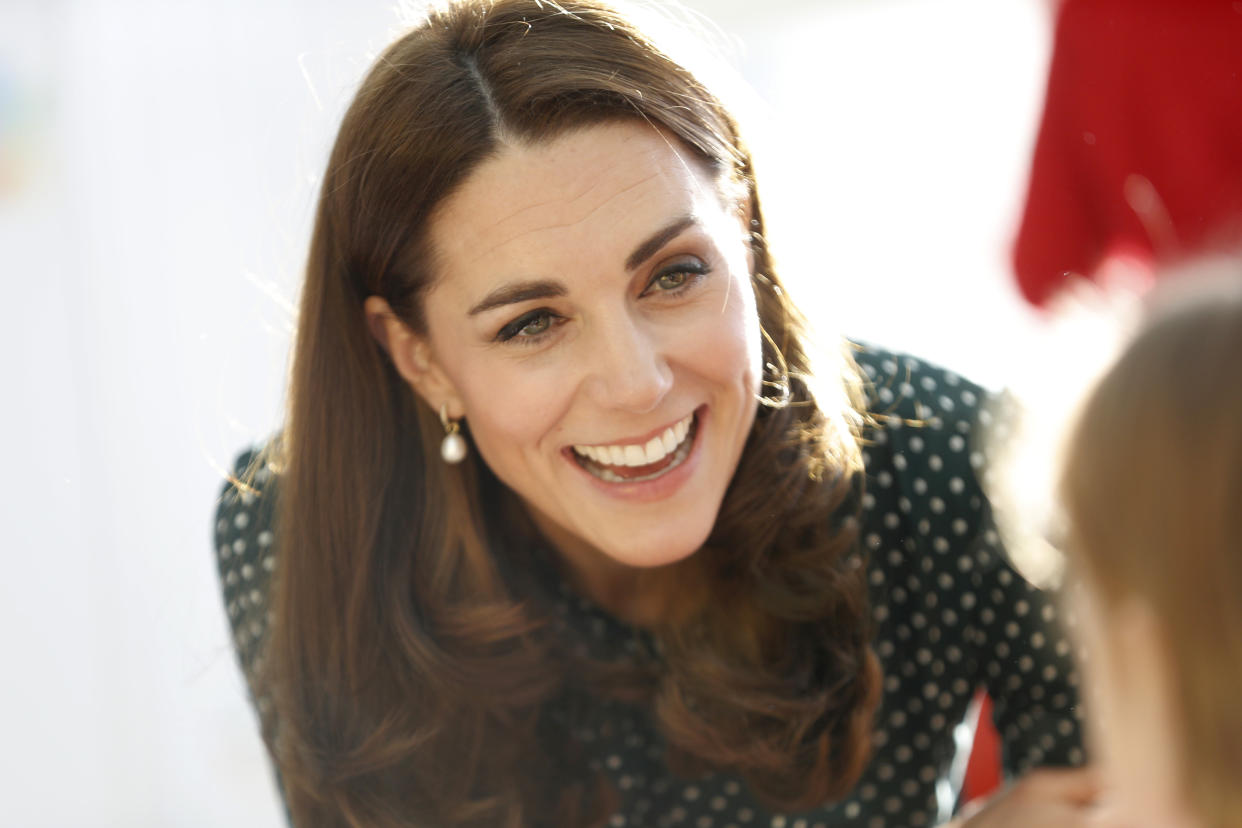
[217,0,1083,827]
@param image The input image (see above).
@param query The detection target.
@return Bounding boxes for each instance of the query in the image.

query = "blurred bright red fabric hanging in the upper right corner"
[1013,0,1242,304]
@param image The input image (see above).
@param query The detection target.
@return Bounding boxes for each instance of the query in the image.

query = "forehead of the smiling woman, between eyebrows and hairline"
[431,123,725,282]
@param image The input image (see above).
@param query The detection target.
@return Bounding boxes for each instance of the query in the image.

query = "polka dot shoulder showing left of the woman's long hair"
[214,448,277,678]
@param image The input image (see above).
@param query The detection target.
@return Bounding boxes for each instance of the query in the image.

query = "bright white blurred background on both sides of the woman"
[0,0,1051,828]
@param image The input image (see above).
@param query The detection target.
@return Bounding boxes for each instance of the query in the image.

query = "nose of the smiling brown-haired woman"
[581,314,673,413]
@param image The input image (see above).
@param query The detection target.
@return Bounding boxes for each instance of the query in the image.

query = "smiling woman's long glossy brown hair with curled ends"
[260,0,879,826]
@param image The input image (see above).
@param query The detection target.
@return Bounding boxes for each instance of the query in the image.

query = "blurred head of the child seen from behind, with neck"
[1062,270,1242,826]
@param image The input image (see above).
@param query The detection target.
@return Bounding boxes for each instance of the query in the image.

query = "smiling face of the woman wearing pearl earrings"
[416,123,761,566]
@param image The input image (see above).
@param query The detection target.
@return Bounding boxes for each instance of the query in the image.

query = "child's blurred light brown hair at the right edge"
[1062,275,1242,826]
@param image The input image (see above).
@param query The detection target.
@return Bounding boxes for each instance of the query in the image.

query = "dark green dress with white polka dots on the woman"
[216,348,1083,828]
